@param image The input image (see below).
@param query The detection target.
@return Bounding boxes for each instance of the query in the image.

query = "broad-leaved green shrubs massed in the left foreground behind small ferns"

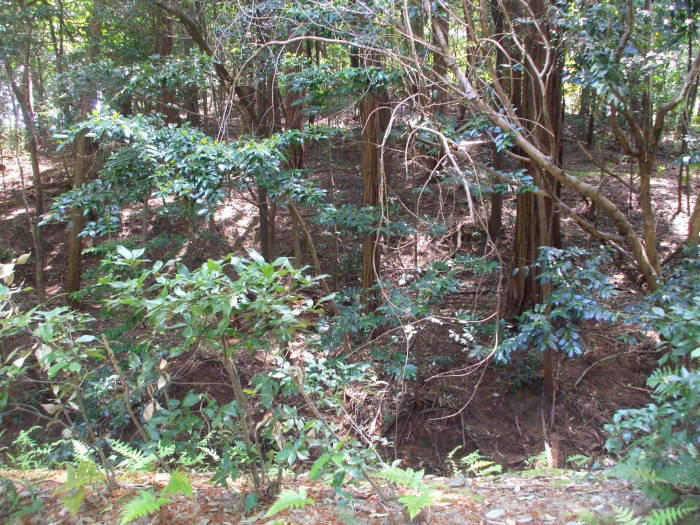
[0,246,377,502]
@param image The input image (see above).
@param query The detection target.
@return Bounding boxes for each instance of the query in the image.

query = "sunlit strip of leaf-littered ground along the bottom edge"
[0,469,650,525]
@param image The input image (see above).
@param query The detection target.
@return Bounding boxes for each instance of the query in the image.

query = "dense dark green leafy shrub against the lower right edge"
[606,250,700,503]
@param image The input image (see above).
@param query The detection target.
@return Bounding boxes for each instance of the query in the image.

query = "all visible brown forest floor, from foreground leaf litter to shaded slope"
[0,128,698,525]
